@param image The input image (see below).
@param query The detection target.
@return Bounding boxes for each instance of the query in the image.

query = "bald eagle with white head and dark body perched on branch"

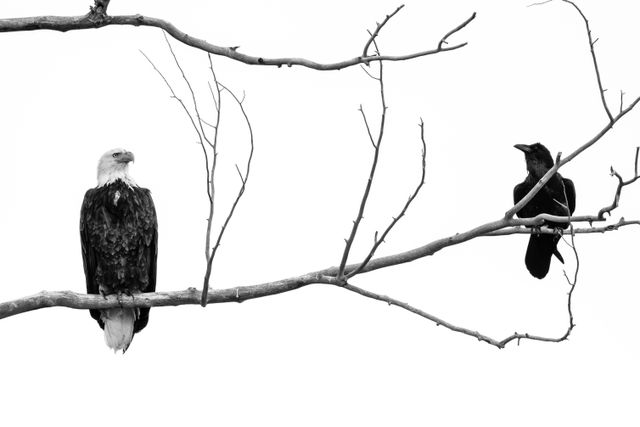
[80,148,158,353]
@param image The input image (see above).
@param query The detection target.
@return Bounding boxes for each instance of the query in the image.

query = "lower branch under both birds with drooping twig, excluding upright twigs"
[0,175,640,348]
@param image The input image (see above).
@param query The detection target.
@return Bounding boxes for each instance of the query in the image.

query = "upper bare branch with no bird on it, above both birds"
[0,8,476,71]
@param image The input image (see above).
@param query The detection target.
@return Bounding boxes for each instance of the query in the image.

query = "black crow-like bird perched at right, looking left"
[513,143,576,279]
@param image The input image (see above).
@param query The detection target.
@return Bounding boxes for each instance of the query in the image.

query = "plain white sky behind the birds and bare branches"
[0,0,640,426]
